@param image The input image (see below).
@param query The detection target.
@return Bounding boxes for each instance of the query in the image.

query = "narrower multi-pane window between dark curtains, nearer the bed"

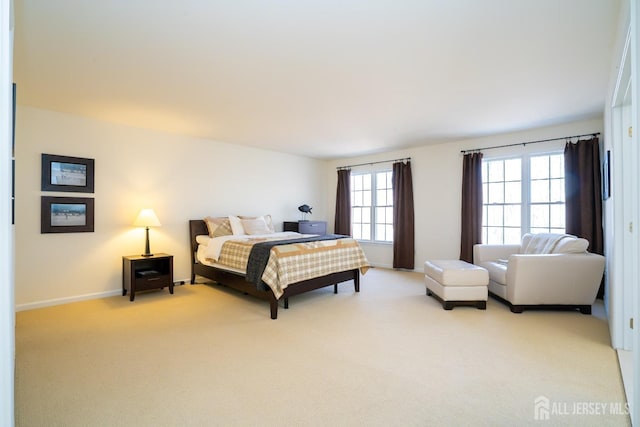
[351,170,393,242]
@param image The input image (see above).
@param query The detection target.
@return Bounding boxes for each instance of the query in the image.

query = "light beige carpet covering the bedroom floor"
[15,268,630,427]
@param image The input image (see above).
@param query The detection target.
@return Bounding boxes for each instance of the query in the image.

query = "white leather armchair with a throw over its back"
[473,234,605,314]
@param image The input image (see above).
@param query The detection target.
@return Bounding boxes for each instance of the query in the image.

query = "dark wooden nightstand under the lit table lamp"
[122,254,173,301]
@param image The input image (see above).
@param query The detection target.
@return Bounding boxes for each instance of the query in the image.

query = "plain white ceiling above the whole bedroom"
[14,0,620,158]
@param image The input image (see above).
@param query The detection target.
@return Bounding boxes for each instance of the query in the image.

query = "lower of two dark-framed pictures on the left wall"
[40,196,94,233]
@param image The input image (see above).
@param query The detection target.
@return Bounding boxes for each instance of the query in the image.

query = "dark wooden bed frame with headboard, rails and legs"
[189,219,360,319]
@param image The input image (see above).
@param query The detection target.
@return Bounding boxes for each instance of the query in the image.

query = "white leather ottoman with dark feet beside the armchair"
[424,260,489,310]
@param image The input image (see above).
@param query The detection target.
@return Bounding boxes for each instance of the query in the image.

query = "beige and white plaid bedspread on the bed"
[218,238,369,298]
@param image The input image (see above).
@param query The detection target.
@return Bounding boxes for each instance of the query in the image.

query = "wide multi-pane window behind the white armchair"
[482,153,565,244]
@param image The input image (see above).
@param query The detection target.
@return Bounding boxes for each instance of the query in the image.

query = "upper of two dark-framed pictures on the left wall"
[42,154,94,193]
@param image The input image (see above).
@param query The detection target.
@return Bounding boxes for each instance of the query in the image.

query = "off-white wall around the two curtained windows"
[327,118,603,271]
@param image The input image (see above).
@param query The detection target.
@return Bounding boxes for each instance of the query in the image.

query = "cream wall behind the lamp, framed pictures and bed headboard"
[15,106,327,309]
